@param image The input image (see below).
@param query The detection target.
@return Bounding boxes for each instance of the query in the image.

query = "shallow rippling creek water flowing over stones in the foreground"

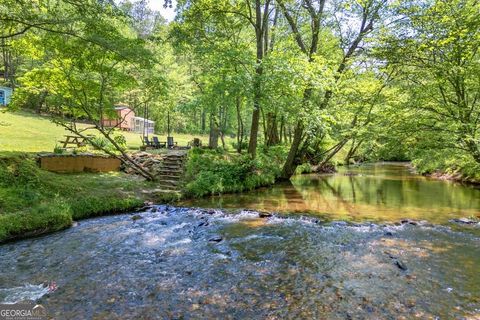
[0,206,480,319]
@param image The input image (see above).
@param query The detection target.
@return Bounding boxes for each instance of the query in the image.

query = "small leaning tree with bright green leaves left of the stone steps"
[9,0,158,180]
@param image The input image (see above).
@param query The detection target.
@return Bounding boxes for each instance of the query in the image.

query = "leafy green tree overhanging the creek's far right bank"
[380,0,480,166]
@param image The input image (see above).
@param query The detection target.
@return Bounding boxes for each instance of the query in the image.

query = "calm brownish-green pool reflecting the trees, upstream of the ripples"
[183,163,480,223]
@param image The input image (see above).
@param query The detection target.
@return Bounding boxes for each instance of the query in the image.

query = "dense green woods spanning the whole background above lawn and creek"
[0,0,480,179]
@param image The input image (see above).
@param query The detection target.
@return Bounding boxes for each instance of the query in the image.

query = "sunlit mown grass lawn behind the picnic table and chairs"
[0,110,223,152]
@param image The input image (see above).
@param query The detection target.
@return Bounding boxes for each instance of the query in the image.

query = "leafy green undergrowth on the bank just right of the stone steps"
[183,146,287,197]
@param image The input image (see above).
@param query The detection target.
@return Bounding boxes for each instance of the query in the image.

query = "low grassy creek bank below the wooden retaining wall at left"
[0,154,149,242]
